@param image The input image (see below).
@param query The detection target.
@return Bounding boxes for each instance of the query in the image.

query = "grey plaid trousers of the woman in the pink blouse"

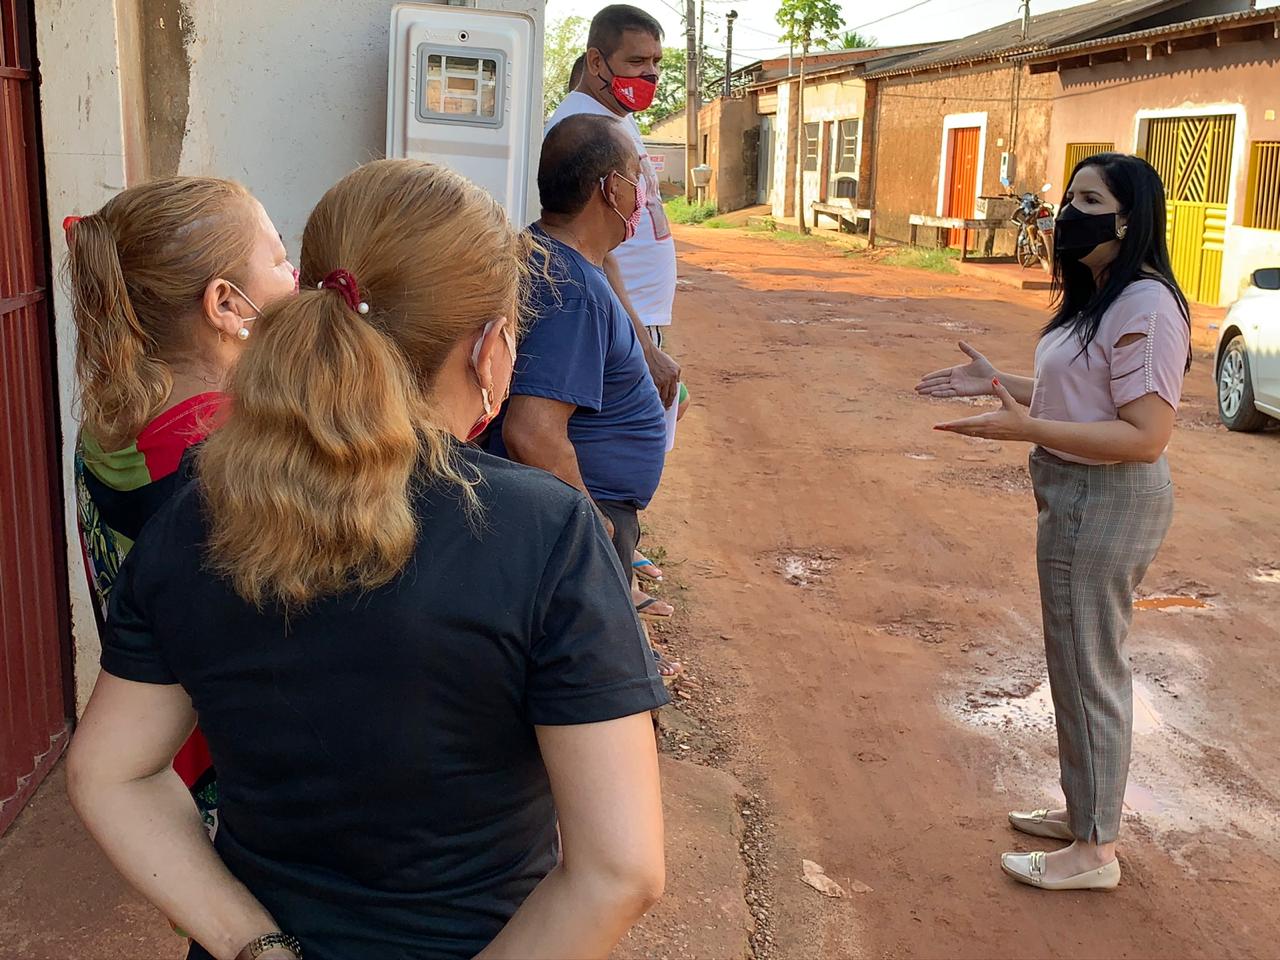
[1030,448,1174,844]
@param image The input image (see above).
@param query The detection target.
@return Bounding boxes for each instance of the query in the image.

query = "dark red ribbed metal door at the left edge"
[0,0,70,832]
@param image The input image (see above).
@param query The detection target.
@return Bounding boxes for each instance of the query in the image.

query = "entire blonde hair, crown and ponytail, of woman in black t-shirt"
[198,160,529,609]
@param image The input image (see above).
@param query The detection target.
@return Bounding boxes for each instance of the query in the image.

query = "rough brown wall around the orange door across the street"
[863,65,1060,242]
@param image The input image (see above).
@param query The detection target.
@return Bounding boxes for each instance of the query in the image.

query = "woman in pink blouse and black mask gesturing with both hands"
[916,154,1190,890]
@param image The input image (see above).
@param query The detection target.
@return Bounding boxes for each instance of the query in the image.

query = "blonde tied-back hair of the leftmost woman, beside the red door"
[67,177,256,451]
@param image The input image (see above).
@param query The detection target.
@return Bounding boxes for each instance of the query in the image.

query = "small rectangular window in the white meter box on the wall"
[417,45,506,127]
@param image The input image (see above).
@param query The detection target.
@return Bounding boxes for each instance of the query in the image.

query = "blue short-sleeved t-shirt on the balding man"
[488,227,667,509]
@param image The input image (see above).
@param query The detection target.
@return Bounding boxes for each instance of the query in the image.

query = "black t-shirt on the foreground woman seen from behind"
[102,449,667,960]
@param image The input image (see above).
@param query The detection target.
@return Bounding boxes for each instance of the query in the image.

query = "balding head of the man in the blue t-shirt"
[538,114,640,218]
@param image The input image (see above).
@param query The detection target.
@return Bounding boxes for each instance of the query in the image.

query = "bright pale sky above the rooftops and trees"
[547,0,1280,65]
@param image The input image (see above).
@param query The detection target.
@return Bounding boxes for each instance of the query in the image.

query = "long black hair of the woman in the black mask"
[1041,154,1192,369]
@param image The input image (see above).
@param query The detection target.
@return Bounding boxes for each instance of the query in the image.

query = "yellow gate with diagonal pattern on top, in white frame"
[1147,115,1235,305]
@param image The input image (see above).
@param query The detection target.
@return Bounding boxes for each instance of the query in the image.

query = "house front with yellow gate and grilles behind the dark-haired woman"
[1027,8,1280,305]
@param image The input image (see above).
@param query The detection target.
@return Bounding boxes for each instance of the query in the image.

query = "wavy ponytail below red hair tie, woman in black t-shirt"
[200,291,420,605]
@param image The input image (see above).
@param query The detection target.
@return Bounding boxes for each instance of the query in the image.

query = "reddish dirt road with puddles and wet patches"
[649,228,1280,957]
